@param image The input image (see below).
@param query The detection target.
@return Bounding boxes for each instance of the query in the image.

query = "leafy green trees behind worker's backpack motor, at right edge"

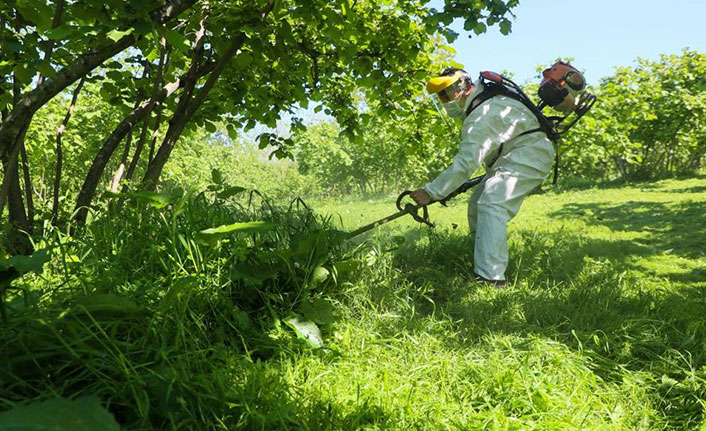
[562,50,706,180]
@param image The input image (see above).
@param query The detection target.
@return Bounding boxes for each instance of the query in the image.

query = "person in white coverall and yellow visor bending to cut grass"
[411,66,585,288]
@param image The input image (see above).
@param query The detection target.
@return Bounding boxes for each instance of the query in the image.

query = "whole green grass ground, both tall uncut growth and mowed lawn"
[0,177,706,430]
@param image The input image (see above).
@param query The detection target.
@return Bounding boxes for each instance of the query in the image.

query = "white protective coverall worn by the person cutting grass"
[424,80,554,280]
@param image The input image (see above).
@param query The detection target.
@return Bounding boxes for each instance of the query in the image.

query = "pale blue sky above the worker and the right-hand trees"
[452,0,706,85]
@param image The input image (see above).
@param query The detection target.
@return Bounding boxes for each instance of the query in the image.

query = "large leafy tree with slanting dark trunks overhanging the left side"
[0,0,517,248]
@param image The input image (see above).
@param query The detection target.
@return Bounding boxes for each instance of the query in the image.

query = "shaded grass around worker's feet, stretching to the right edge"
[376,195,706,429]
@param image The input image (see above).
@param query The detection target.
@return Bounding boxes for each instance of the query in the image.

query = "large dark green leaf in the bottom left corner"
[0,396,120,431]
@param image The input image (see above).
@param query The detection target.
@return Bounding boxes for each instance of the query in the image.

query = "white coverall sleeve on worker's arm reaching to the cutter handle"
[424,97,516,200]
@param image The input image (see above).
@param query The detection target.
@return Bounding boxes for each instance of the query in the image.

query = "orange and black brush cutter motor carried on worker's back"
[537,61,586,113]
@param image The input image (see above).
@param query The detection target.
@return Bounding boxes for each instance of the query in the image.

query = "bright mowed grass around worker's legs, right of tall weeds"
[283,177,706,430]
